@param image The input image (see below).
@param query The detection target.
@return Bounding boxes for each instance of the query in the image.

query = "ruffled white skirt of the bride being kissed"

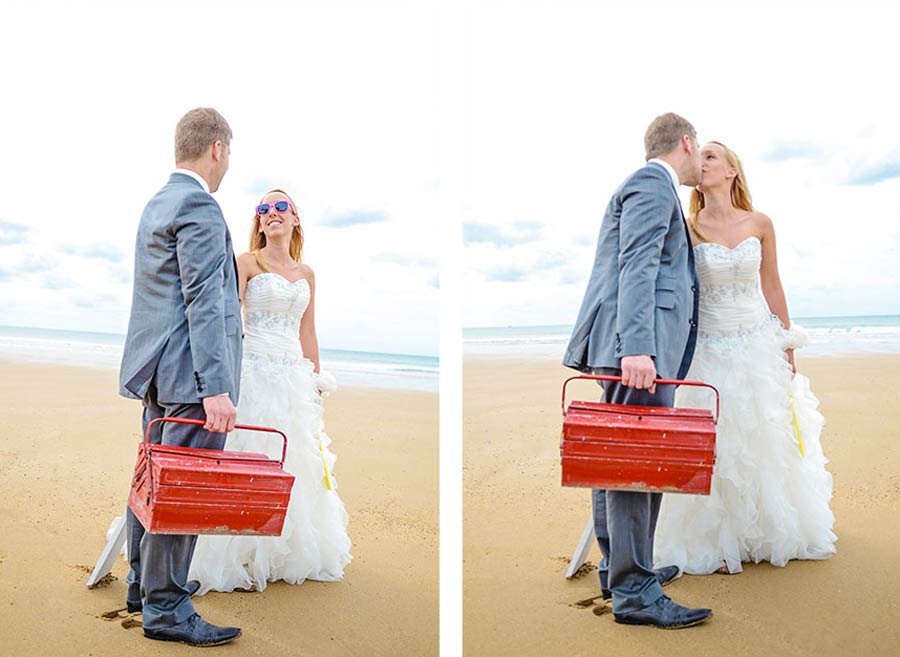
[654,318,837,574]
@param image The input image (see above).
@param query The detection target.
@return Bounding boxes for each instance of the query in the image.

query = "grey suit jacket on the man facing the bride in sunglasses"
[119,173,242,404]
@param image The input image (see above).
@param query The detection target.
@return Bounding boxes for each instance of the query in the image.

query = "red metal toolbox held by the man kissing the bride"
[559,375,719,495]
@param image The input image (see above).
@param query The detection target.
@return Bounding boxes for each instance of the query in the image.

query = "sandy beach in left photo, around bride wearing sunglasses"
[0,360,438,657]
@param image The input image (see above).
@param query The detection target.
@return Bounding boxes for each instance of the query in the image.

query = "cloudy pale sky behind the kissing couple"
[462,2,900,327]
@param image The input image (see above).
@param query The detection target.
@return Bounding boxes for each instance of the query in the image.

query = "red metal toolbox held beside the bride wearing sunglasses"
[128,417,294,536]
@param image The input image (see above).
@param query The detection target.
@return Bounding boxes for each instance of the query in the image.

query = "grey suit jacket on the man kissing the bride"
[563,162,700,379]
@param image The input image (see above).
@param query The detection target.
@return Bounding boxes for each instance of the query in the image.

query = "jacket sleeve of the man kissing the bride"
[616,172,675,357]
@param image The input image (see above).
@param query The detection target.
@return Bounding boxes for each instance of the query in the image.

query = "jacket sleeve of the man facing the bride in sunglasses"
[175,191,235,398]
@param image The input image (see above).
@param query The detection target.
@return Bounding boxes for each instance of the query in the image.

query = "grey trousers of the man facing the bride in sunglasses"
[126,384,226,630]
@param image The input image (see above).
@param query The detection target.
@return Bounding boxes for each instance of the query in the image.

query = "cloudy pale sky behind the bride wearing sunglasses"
[0,3,439,355]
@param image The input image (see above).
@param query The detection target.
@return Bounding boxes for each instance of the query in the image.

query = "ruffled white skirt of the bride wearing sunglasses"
[190,341,351,594]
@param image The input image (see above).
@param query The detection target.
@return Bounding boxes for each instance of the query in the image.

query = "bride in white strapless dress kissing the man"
[654,142,837,574]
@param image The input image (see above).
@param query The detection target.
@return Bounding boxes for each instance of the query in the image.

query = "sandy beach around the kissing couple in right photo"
[463,353,900,657]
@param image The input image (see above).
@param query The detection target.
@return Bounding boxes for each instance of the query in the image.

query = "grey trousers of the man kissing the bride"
[592,368,675,614]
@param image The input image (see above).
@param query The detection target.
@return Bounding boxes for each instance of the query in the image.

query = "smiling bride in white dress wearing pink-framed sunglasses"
[190,190,351,594]
